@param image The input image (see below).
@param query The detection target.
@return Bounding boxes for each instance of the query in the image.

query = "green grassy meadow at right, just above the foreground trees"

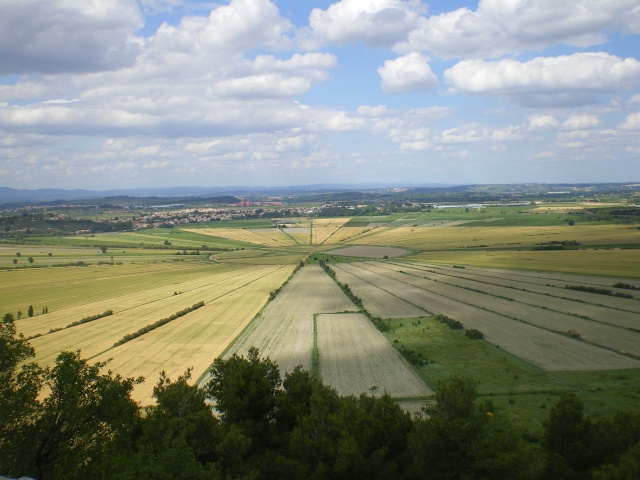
[385,317,640,436]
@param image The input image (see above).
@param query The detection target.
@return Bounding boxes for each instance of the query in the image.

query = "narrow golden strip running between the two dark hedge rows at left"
[26,266,282,365]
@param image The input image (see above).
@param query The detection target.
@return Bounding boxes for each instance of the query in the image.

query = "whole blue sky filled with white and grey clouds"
[0,0,640,190]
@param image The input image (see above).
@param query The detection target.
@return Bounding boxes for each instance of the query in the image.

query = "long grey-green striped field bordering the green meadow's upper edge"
[340,262,640,371]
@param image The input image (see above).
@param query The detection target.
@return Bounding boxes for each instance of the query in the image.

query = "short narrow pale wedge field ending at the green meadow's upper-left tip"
[331,264,425,318]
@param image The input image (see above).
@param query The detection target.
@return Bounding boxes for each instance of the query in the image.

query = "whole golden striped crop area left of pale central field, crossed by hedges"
[7,256,294,402]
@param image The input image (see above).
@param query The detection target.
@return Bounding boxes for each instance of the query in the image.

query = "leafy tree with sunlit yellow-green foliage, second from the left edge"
[24,352,142,480]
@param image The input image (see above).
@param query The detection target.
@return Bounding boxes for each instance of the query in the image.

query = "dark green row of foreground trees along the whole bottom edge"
[0,316,640,480]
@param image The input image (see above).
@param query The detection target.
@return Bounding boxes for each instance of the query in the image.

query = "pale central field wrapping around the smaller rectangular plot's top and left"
[225,265,357,376]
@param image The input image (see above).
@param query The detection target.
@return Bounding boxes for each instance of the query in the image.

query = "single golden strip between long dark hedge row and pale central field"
[95,267,292,404]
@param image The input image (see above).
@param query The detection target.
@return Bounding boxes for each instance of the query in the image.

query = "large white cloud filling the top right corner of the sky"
[395,0,640,58]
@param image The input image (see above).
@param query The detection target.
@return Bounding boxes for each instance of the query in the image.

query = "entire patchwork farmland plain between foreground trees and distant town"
[5,191,640,424]
